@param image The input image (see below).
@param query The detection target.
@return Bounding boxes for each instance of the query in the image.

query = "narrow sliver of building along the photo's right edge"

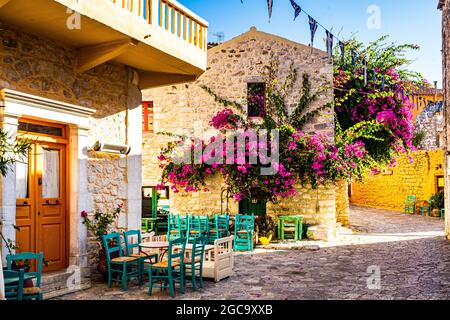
[439,0,450,239]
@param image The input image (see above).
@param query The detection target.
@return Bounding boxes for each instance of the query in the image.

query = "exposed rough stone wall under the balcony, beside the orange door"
[0,23,141,276]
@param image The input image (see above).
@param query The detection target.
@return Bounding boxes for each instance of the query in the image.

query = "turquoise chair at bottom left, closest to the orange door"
[6,252,44,300]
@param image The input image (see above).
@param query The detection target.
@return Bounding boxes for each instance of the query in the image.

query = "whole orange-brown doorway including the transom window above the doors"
[16,119,68,272]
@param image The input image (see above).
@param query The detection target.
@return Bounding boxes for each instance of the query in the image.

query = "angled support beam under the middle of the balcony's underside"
[76,39,138,73]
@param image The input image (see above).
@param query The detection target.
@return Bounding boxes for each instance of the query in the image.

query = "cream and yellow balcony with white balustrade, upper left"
[0,0,208,89]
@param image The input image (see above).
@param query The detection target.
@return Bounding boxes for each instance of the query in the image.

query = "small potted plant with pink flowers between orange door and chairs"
[81,204,123,279]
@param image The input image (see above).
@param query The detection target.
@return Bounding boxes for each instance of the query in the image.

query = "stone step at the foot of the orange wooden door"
[41,271,91,299]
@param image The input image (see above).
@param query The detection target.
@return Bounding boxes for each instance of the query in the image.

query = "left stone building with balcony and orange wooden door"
[0,0,208,297]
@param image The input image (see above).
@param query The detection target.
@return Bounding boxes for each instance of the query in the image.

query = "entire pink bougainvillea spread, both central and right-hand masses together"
[158,38,428,202]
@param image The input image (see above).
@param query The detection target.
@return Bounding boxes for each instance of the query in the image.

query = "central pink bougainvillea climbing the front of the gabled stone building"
[159,63,369,202]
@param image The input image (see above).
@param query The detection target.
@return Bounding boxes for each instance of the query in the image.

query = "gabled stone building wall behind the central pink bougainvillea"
[143,27,348,239]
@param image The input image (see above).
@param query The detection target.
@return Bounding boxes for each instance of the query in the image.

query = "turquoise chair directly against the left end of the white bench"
[185,236,208,291]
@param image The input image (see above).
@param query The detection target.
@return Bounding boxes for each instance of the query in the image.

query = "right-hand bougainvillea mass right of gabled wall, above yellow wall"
[334,36,427,167]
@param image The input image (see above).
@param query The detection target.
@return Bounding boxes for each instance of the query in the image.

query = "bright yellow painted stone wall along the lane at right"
[351,150,444,211]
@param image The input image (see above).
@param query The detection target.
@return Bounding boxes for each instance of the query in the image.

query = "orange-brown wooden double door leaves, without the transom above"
[16,143,66,271]
